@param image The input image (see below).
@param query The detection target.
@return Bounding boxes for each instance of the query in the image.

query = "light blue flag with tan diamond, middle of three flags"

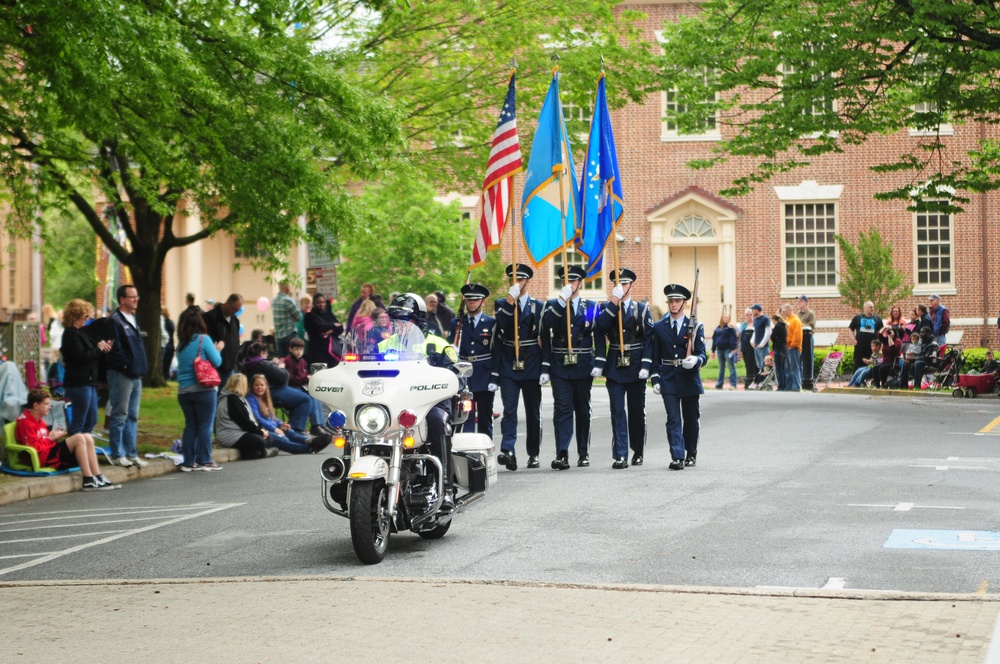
[521,73,580,267]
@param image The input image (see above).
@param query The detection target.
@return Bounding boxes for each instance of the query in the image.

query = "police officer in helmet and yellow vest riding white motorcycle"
[378,293,462,508]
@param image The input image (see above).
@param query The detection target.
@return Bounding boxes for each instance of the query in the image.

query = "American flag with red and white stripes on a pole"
[469,74,521,270]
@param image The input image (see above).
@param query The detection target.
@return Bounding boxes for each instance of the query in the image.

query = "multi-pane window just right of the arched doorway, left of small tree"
[784,203,837,288]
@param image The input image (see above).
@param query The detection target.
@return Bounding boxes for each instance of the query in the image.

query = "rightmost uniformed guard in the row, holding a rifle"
[653,284,708,470]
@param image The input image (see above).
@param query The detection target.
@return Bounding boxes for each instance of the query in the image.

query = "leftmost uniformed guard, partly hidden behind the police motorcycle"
[448,284,496,438]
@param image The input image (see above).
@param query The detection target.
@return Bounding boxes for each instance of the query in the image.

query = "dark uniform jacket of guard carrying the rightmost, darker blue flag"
[594,301,653,383]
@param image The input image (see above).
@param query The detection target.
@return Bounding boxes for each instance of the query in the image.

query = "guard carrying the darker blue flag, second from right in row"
[593,268,653,469]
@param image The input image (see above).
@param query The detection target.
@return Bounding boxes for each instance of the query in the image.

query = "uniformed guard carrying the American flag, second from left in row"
[489,264,543,470]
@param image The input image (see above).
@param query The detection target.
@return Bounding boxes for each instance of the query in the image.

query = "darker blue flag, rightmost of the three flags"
[577,74,625,281]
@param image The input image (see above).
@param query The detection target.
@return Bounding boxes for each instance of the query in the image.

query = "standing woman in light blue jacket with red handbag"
[177,312,225,473]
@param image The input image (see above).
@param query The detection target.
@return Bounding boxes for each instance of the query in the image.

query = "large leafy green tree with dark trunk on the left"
[0,0,399,384]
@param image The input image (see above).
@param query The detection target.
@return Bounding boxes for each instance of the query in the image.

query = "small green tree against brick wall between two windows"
[836,229,913,311]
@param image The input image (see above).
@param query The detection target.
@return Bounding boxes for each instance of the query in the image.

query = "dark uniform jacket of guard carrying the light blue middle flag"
[542,298,600,380]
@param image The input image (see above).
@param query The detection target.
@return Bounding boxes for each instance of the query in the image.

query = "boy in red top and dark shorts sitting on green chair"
[14,389,121,491]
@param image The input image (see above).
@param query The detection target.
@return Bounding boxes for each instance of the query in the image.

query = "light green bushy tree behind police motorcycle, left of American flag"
[337,178,475,306]
